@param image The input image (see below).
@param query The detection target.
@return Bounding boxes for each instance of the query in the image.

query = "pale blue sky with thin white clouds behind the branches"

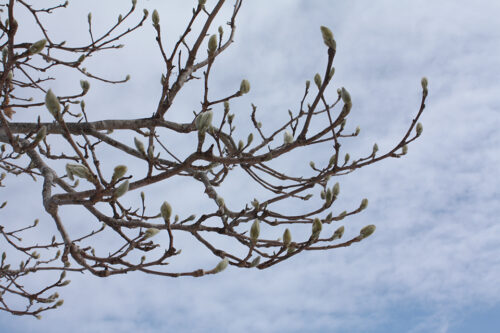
[0,0,500,333]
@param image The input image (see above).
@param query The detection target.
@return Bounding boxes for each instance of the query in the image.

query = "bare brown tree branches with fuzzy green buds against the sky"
[0,0,427,317]
